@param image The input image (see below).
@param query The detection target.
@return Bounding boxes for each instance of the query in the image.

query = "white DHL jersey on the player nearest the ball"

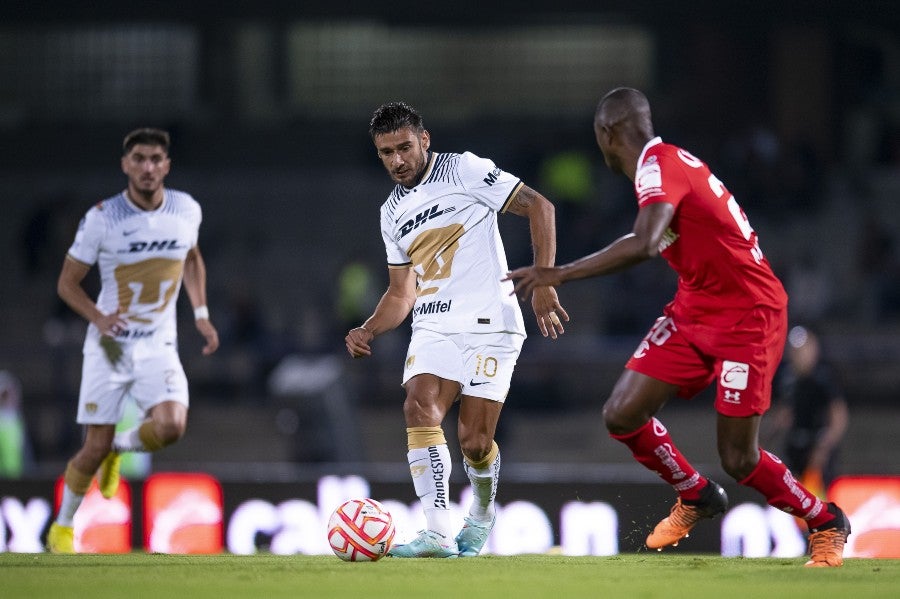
[381,152,525,336]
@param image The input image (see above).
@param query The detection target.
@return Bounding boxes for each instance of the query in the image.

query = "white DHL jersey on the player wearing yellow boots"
[68,189,202,353]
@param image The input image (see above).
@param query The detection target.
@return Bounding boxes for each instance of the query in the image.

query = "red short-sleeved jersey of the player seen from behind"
[634,137,787,327]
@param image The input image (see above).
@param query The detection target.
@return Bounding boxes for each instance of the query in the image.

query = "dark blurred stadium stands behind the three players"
[0,0,900,482]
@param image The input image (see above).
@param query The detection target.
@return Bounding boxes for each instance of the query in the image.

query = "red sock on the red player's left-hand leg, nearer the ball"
[610,418,706,501]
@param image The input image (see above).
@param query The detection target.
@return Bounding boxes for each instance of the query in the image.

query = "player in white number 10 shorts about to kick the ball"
[345,102,568,557]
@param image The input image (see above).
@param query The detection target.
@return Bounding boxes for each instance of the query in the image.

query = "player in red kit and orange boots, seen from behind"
[507,88,850,567]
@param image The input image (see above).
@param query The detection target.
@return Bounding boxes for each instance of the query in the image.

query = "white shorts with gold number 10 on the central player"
[403,329,525,403]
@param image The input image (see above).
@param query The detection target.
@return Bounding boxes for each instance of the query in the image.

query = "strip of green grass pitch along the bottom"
[0,552,900,599]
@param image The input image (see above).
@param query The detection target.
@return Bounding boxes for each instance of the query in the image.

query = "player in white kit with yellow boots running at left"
[47,129,219,553]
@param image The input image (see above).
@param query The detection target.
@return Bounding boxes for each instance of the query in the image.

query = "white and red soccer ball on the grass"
[328,499,395,562]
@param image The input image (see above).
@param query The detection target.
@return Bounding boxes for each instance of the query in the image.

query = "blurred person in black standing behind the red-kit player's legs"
[771,326,848,498]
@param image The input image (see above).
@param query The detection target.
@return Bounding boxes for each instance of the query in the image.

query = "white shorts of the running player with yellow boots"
[76,345,188,424]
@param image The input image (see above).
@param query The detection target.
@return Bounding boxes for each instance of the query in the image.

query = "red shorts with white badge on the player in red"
[625,306,787,417]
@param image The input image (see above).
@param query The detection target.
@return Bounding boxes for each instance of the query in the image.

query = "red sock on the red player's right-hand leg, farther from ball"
[738,449,834,528]
